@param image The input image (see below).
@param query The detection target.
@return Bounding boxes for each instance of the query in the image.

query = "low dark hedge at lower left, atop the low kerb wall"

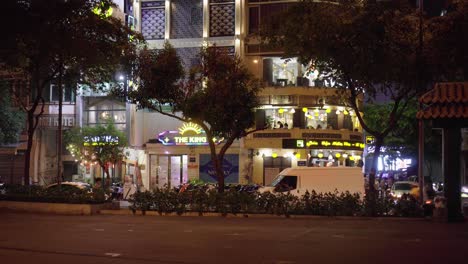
[0,185,106,204]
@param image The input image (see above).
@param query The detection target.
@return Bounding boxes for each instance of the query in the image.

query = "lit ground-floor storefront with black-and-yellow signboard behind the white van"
[244,128,365,184]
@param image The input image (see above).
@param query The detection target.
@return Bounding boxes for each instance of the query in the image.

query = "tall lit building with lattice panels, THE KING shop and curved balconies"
[117,0,364,188]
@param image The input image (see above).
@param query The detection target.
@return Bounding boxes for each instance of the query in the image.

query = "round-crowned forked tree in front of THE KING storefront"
[121,43,260,192]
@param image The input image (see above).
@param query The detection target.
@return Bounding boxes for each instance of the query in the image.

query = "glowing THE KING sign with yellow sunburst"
[158,122,223,146]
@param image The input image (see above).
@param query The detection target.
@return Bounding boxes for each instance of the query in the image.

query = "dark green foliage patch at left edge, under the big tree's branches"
[0,82,25,145]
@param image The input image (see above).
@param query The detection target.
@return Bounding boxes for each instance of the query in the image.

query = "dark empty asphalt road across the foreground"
[0,212,468,264]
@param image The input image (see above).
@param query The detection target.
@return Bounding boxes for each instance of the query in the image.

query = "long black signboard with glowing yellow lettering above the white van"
[283,139,364,150]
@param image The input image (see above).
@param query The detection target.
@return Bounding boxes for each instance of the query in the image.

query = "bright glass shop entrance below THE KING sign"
[150,155,188,188]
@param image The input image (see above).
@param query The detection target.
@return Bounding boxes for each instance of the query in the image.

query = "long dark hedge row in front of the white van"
[130,189,422,217]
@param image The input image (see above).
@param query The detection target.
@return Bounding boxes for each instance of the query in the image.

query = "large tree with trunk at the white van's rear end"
[260,0,425,214]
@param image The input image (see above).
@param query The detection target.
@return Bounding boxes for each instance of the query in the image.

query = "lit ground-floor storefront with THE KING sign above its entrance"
[146,123,240,189]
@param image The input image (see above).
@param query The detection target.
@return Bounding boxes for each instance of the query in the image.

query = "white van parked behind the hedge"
[259,167,364,197]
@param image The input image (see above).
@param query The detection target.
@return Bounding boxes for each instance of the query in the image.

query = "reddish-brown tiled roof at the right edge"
[416,82,468,119]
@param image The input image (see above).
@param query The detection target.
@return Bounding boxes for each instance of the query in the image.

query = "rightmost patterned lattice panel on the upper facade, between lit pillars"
[210,3,235,37]
